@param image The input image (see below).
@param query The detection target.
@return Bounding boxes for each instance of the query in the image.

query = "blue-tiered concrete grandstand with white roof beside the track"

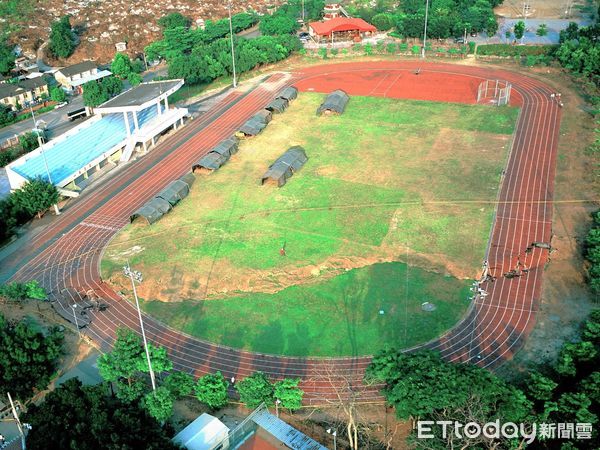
[6,80,188,195]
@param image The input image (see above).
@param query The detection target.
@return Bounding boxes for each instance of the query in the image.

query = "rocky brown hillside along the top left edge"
[9,0,281,65]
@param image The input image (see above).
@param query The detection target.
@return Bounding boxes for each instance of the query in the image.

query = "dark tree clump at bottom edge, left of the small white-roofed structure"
[21,378,178,450]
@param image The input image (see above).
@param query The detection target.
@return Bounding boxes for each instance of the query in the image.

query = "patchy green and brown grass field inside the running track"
[102,93,518,356]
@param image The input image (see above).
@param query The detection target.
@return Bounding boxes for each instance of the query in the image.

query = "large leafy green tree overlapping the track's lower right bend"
[366,348,532,447]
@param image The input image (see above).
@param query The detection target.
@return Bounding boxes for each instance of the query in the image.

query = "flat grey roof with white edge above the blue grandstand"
[95,80,183,114]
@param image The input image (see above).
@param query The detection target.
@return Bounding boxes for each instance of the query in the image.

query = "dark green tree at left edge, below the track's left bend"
[0,314,63,401]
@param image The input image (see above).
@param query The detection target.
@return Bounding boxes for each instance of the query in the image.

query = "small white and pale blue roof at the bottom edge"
[172,413,229,450]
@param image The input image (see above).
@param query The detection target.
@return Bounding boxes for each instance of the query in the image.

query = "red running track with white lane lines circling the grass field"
[3,61,560,402]
